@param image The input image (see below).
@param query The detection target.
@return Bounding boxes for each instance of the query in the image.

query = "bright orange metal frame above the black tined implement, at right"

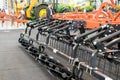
[53,2,120,29]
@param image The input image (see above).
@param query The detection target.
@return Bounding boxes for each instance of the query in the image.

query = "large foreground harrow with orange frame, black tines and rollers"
[18,2,120,80]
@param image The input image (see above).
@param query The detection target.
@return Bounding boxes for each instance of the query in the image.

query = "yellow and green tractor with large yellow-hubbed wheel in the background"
[24,0,53,19]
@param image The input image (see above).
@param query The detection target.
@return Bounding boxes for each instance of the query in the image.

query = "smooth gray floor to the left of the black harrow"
[0,30,56,80]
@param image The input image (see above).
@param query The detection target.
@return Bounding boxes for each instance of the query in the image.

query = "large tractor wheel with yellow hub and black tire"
[35,5,47,19]
